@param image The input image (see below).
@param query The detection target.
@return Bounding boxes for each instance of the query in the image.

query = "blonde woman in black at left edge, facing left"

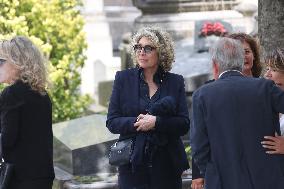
[0,36,54,189]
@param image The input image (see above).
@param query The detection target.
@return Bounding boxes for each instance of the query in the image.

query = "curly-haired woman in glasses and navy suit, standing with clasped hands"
[106,28,189,189]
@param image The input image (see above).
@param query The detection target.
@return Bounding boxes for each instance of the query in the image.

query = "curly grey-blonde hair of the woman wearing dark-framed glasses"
[130,27,175,72]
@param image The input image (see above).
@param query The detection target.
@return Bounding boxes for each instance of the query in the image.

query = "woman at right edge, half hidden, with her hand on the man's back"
[262,48,284,154]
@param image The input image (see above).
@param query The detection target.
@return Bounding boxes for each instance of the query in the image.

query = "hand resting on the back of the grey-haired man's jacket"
[261,134,284,154]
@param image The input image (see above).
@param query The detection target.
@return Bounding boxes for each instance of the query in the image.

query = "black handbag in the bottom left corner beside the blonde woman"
[0,133,14,189]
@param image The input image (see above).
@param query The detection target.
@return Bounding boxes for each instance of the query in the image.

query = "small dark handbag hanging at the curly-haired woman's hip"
[109,137,134,166]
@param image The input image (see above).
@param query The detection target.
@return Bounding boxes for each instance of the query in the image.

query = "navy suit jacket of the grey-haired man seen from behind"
[190,71,284,189]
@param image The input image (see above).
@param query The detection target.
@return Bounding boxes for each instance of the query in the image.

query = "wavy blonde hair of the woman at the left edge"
[0,36,47,94]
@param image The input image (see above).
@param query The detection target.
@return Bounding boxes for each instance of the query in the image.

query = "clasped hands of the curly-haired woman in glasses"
[134,114,156,131]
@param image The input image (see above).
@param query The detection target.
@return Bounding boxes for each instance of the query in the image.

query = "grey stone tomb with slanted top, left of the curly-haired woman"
[53,115,118,175]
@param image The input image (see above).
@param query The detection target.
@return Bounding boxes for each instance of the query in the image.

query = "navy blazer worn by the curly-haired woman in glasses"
[106,68,189,174]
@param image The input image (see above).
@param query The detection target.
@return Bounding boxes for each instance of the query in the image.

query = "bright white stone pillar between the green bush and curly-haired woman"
[81,0,120,103]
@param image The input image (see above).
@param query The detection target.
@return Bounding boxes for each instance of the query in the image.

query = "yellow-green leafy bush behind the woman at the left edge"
[0,0,91,122]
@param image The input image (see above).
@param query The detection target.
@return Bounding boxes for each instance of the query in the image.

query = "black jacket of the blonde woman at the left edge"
[0,81,54,182]
